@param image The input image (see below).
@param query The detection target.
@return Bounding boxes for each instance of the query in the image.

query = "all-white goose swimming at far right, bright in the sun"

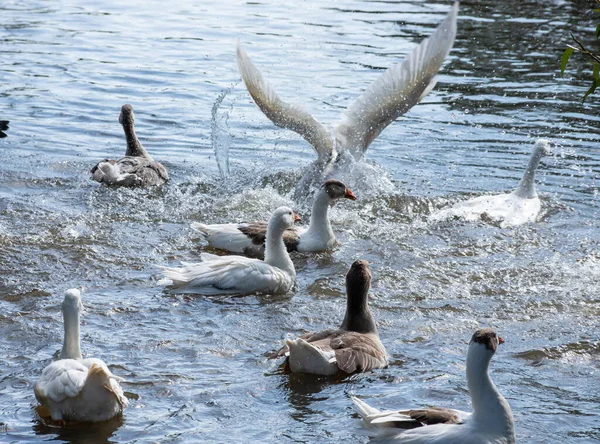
[429,139,552,227]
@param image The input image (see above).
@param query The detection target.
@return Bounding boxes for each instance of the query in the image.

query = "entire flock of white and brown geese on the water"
[34,3,550,443]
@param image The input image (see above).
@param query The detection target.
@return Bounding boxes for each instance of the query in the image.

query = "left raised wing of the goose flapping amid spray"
[237,43,333,161]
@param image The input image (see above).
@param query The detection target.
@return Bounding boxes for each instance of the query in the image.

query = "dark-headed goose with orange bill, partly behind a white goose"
[191,179,356,256]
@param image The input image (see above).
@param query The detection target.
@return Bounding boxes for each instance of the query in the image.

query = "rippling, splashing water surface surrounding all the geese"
[0,0,600,443]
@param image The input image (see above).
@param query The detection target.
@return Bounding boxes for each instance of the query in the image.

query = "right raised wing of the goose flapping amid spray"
[334,2,458,157]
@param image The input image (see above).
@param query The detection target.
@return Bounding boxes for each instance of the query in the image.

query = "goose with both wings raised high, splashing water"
[237,2,458,199]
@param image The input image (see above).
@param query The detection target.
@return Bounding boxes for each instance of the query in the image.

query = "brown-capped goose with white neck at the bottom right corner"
[352,328,515,444]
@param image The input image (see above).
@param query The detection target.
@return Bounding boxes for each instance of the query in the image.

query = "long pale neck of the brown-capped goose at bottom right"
[467,342,514,436]
